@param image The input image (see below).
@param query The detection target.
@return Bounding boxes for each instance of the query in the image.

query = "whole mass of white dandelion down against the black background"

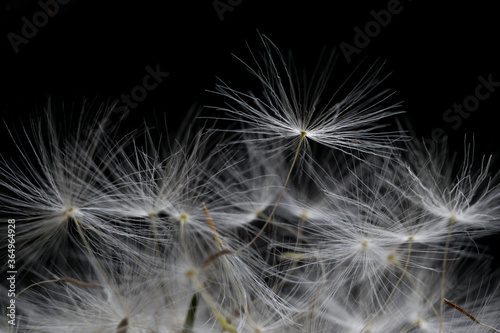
[0,36,500,333]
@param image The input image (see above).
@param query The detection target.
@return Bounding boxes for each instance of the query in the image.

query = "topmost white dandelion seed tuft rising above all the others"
[209,36,401,158]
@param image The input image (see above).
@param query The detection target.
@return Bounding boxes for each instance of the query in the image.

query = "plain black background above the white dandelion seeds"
[0,0,500,262]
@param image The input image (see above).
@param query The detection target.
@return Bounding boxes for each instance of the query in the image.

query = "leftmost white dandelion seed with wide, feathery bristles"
[0,102,135,272]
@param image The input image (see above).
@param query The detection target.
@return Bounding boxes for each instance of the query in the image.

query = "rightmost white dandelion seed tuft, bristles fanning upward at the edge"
[400,137,500,236]
